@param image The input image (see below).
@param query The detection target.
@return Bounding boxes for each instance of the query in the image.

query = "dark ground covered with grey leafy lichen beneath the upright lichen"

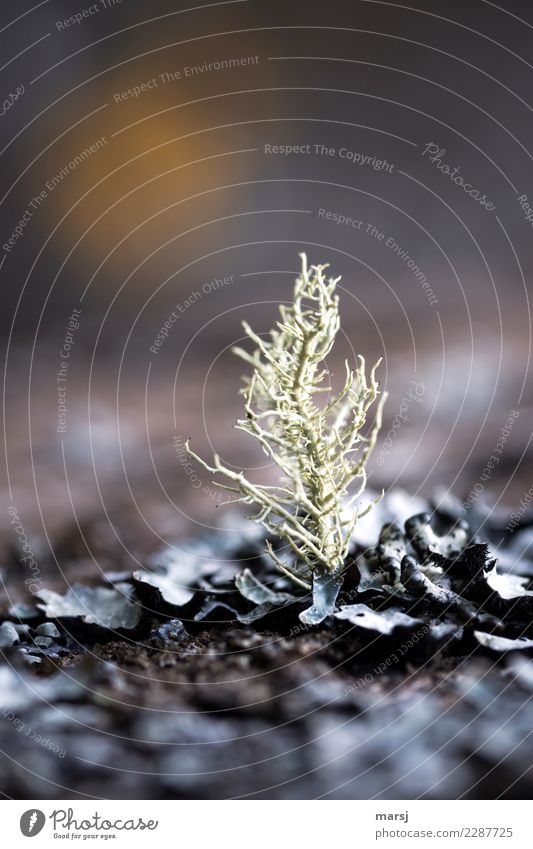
[0,494,533,799]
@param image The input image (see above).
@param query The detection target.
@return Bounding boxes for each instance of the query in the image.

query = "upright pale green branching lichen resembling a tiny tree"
[186,254,386,588]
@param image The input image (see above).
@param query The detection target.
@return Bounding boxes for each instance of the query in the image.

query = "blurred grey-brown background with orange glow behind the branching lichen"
[0,0,533,565]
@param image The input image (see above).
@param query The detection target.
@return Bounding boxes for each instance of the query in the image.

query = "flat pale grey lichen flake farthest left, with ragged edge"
[38,584,141,630]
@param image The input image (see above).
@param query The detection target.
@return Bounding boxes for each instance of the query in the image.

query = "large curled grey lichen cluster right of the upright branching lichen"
[359,513,533,650]
